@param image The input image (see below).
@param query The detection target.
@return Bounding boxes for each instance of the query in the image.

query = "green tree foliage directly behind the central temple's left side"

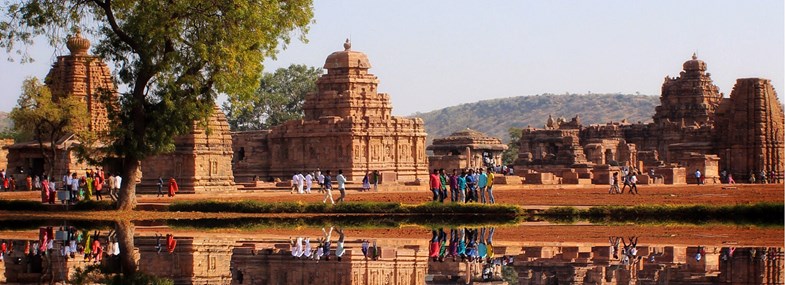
[223,64,322,131]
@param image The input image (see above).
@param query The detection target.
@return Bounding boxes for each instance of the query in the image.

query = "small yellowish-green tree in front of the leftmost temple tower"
[10,77,92,175]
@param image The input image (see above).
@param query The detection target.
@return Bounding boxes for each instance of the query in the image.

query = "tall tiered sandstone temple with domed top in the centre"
[232,40,428,183]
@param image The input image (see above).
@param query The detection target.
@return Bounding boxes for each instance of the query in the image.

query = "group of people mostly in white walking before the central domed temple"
[289,169,381,205]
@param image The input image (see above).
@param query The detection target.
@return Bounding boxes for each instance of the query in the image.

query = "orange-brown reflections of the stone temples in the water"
[0,232,785,285]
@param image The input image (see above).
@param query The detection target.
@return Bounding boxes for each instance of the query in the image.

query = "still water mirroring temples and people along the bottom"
[0,220,785,285]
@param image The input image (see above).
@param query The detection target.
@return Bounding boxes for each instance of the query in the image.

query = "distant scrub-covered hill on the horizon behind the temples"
[412,94,660,144]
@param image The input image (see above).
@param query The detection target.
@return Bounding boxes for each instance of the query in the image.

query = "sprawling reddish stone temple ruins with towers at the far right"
[516,55,785,184]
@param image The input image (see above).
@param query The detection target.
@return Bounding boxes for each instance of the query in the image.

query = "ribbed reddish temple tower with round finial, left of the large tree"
[44,31,117,132]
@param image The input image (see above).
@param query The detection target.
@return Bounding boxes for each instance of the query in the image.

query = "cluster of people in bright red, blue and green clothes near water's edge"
[428,167,496,204]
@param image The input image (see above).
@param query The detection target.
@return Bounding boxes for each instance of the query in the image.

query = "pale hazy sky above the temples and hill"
[0,0,785,115]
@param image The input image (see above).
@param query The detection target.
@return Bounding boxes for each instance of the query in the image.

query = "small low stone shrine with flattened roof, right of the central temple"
[426,129,508,170]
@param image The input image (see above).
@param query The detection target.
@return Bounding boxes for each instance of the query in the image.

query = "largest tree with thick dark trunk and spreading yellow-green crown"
[0,0,313,210]
